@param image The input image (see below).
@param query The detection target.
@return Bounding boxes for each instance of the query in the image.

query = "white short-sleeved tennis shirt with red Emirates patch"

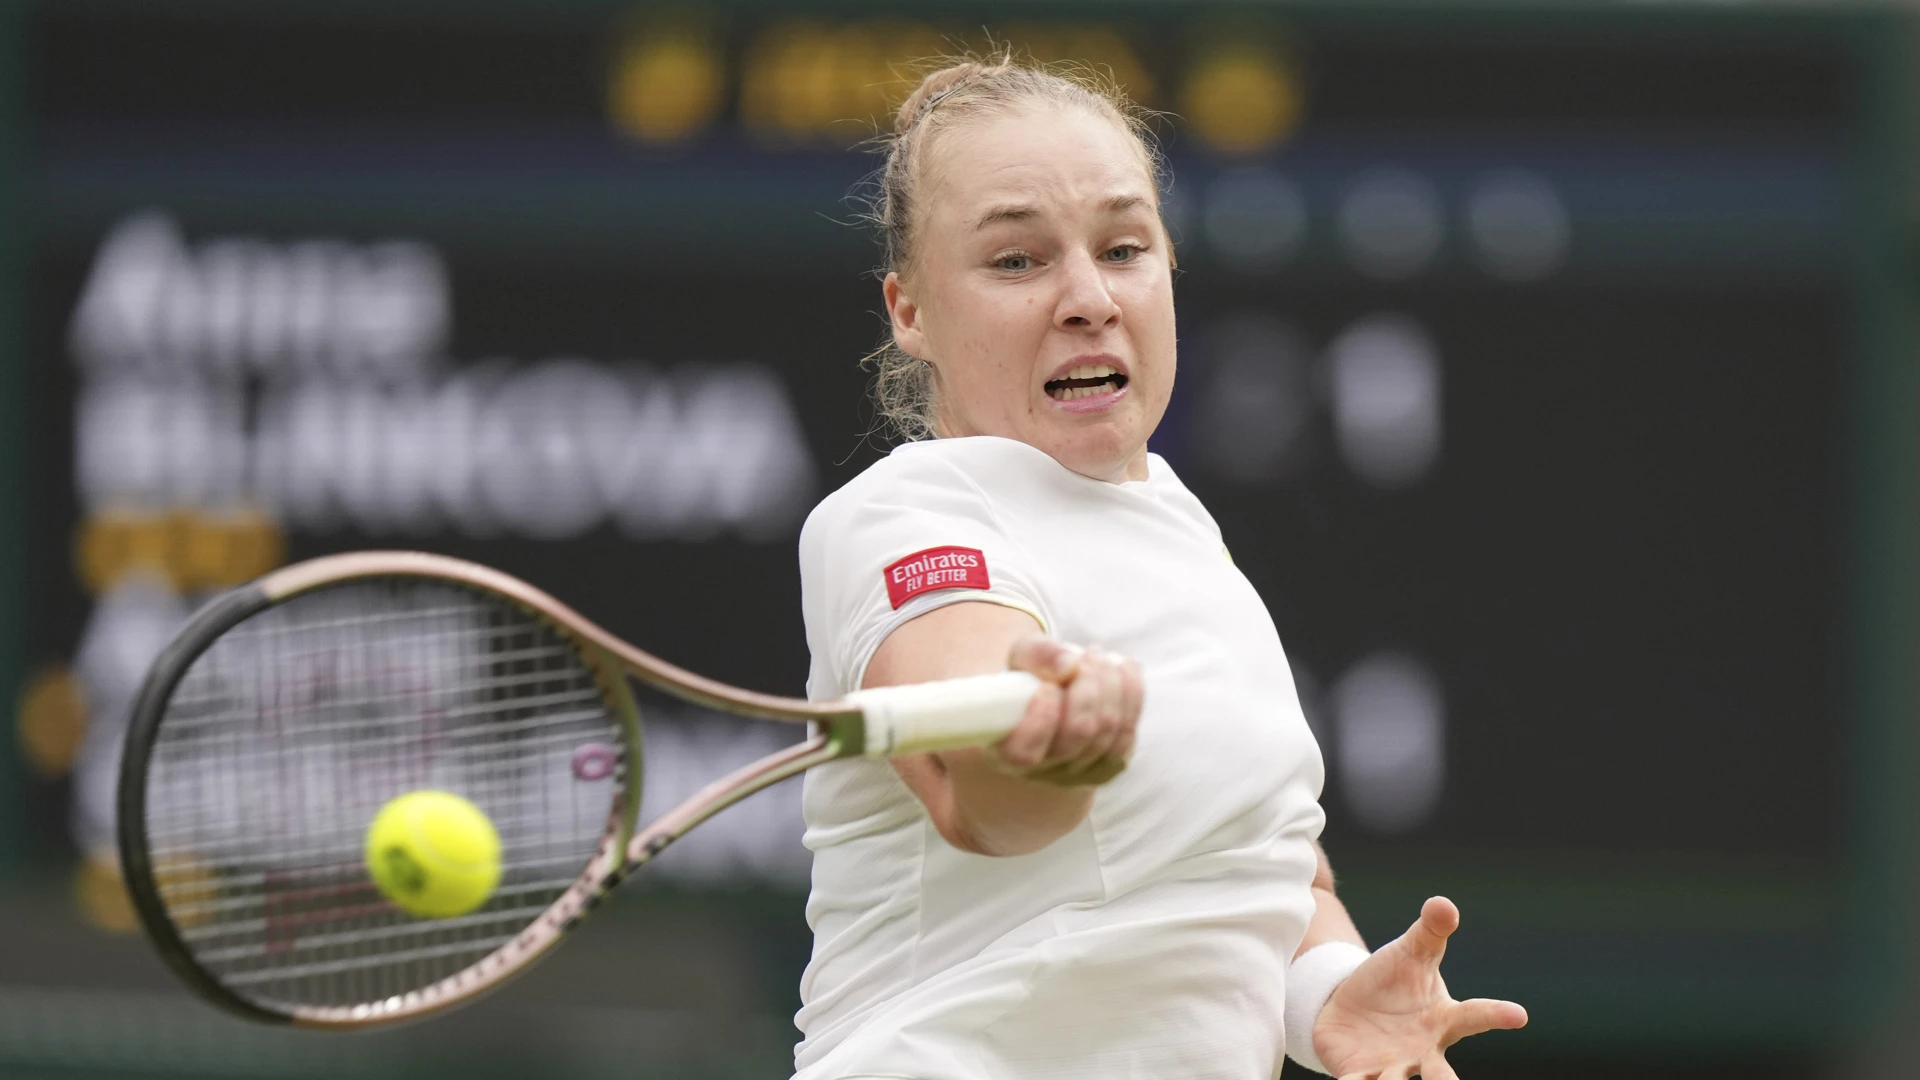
[795,436,1325,1080]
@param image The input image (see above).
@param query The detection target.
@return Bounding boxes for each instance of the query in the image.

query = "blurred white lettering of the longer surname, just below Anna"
[75,359,816,540]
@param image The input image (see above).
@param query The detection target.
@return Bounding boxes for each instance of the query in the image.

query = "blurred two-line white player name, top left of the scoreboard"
[71,211,816,540]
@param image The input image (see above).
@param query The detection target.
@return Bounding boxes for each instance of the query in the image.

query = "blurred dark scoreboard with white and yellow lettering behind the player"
[6,2,1916,1040]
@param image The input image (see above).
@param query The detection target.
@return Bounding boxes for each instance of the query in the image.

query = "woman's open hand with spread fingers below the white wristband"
[1313,896,1526,1080]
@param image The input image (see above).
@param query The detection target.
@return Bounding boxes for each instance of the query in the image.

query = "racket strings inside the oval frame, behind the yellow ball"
[146,578,637,1011]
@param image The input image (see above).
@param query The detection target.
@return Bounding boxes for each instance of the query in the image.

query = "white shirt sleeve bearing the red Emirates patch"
[801,452,1056,700]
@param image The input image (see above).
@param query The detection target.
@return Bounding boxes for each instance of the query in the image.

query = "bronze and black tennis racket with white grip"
[119,552,1039,1028]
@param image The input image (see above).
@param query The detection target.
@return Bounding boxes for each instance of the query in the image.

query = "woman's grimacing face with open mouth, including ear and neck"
[885,106,1175,482]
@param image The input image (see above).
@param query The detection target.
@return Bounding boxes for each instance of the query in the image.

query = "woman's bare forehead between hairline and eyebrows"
[922,106,1158,223]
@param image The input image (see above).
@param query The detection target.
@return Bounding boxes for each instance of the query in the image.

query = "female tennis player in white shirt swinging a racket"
[795,61,1526,1080]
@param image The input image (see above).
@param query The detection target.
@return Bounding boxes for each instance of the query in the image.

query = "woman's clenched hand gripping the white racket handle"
[987,634,1146,788]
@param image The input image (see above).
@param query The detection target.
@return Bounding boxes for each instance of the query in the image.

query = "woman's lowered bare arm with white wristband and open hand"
[1286,844,1526,1080]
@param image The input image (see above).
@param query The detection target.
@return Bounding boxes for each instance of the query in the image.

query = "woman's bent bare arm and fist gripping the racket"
[862,601,1144,855]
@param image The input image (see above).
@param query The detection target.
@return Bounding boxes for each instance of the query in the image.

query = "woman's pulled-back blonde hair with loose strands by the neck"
[862,50,1164,440]
